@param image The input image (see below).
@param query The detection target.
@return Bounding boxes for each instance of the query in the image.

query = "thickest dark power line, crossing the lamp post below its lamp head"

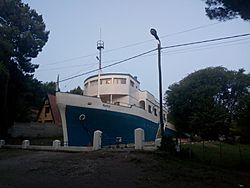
[59,33,250,82]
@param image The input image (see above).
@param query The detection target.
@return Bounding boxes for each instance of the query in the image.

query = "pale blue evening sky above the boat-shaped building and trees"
[23,0,250,98]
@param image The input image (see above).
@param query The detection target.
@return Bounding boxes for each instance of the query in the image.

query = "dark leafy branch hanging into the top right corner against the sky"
[206,0,250,21]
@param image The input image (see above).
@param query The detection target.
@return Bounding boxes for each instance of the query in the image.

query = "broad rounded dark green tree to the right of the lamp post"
[165,67,250,142]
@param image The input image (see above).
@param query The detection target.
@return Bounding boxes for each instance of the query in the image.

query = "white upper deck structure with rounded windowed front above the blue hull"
[84,73,167,120]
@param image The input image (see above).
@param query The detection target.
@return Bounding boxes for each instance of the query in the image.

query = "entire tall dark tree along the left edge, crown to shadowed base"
[0,0,49,136]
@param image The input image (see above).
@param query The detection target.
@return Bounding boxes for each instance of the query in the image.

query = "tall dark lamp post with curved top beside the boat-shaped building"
[150,28,164,145]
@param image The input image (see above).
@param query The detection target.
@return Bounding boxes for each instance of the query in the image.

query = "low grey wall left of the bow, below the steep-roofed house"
[9,122,63,138]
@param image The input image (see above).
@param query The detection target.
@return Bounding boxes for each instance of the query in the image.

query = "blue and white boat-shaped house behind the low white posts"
[56,73,175,146]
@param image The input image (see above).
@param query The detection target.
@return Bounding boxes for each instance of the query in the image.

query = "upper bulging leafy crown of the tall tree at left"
[0,0,49,73]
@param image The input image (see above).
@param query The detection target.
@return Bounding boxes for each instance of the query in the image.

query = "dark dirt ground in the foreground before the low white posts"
[0,149,250,188]
